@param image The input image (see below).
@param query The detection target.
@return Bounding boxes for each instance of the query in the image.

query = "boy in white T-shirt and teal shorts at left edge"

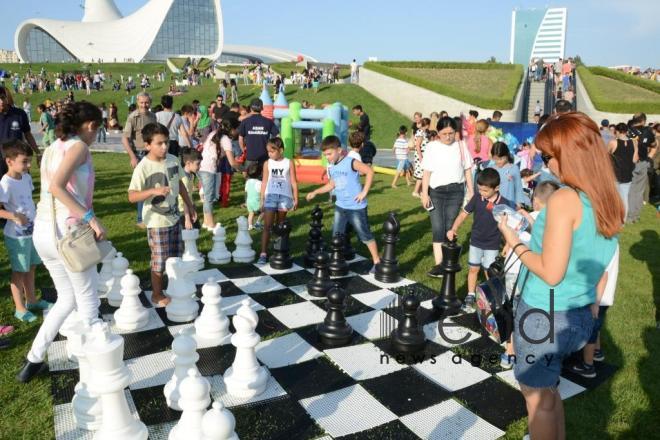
[0,140,52,322]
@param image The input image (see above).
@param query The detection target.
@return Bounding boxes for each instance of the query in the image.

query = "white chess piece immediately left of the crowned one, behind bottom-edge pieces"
[163,327,199,411]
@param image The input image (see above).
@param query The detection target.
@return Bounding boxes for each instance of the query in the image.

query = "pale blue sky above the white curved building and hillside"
[0,0,660,68]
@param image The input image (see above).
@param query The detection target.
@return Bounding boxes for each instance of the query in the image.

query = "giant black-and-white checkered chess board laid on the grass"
[45,257,615,440]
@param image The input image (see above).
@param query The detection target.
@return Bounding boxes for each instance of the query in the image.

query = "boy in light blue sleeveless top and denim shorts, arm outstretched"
[305,136,380,273]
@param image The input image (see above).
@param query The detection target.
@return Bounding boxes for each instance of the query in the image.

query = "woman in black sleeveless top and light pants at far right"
[607,122,639,216]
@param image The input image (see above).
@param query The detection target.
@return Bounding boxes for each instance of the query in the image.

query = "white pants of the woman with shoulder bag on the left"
[27,221,101,363]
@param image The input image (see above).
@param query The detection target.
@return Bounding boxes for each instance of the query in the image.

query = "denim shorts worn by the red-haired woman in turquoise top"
[513,297,594,388]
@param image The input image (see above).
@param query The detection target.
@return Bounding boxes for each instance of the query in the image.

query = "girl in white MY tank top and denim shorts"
[257,137,298,265]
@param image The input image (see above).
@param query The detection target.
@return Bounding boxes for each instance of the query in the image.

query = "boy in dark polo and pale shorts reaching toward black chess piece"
[447,168,515,313]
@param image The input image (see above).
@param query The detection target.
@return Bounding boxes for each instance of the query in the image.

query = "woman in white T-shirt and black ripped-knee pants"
[421,118,473,278]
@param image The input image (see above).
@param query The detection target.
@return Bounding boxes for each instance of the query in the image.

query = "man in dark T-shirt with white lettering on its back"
[238,98,280,174]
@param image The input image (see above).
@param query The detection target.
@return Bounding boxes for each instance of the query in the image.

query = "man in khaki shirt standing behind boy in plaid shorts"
[121,92,158,229]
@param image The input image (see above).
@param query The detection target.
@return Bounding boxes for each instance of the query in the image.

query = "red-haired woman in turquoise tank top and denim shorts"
[499,112,624,440]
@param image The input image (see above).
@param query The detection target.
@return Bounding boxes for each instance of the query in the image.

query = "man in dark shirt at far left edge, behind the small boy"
[0,85,41,176]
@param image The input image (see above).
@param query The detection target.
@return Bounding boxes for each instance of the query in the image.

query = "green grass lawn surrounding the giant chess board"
[0,153,660,440]
